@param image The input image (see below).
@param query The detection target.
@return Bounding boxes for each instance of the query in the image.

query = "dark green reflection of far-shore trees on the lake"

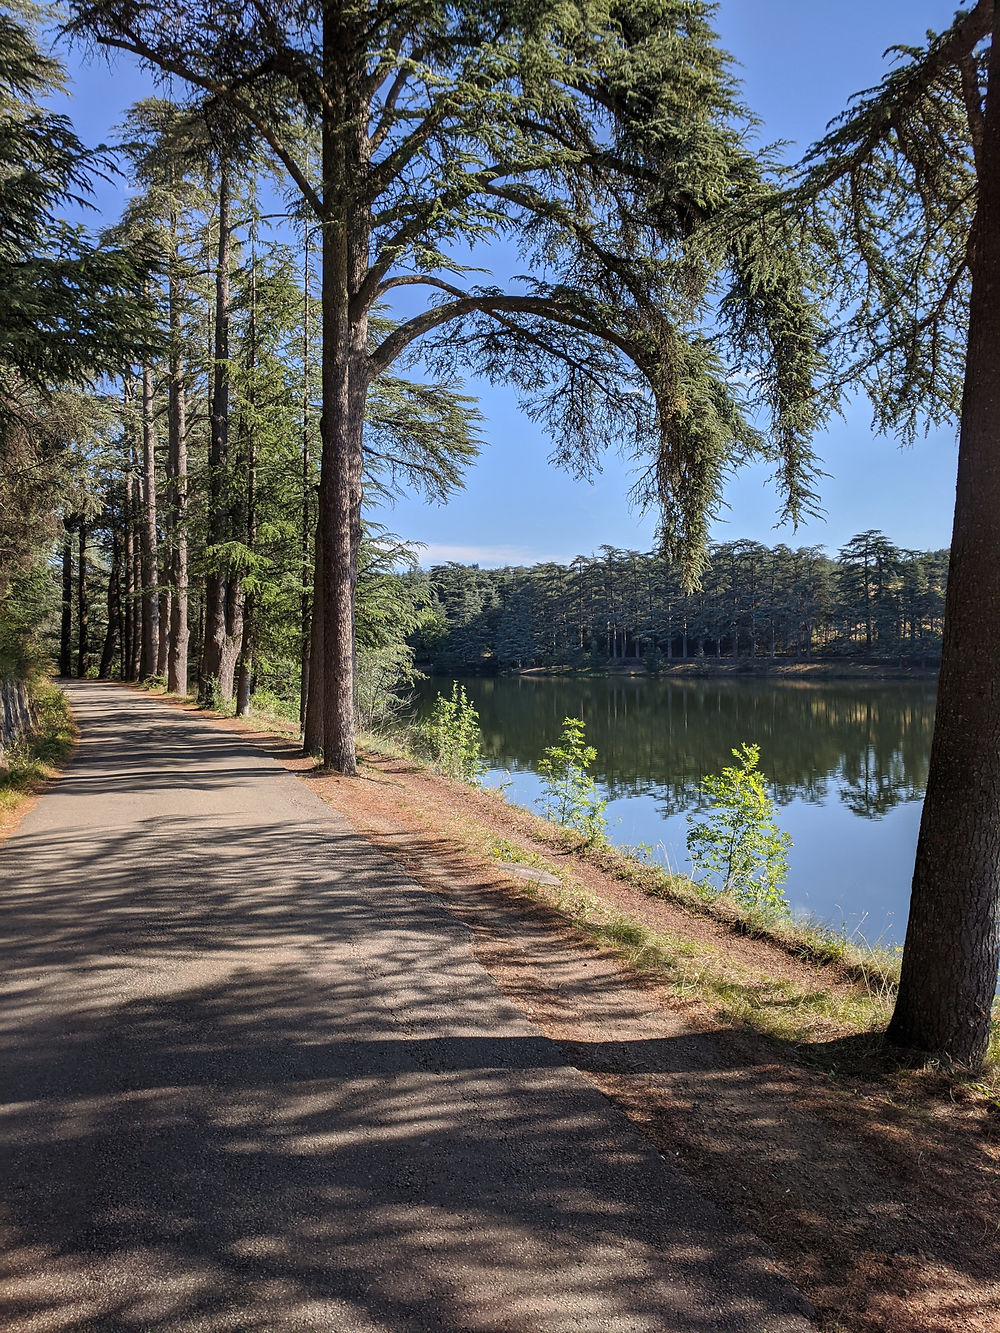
[424,676,935,818]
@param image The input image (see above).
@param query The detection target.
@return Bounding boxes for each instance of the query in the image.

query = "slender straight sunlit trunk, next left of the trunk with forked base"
[167,217,189,694]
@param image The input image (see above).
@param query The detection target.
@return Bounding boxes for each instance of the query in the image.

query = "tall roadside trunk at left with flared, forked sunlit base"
[199,153,241,701]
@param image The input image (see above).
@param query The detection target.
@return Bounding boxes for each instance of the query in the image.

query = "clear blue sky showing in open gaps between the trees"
[56,0,956,564]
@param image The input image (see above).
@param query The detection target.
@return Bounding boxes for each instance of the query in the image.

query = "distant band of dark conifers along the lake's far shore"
[412,531,948,673]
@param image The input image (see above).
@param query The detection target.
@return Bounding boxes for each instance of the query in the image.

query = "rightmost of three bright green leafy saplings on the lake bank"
[688,742,792,909]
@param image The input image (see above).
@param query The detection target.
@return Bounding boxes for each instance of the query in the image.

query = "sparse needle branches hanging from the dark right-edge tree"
[785,3,992,440]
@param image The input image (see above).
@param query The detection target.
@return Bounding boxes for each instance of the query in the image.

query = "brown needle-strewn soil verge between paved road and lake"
[117,693,1000,1333]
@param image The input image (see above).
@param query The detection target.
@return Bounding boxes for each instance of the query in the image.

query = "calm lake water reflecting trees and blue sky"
[419,676,935,944]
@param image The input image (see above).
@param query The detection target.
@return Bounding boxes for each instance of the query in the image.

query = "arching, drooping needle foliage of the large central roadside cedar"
[69,0,827,581]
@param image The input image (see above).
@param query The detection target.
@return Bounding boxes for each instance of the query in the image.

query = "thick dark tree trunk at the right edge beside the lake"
[888,39,1000,1068]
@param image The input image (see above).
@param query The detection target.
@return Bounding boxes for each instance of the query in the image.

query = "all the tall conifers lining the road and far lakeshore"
[0,0,1000,1064]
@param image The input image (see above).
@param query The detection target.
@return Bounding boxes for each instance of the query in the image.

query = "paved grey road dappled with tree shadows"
[0,684,809,1333]
